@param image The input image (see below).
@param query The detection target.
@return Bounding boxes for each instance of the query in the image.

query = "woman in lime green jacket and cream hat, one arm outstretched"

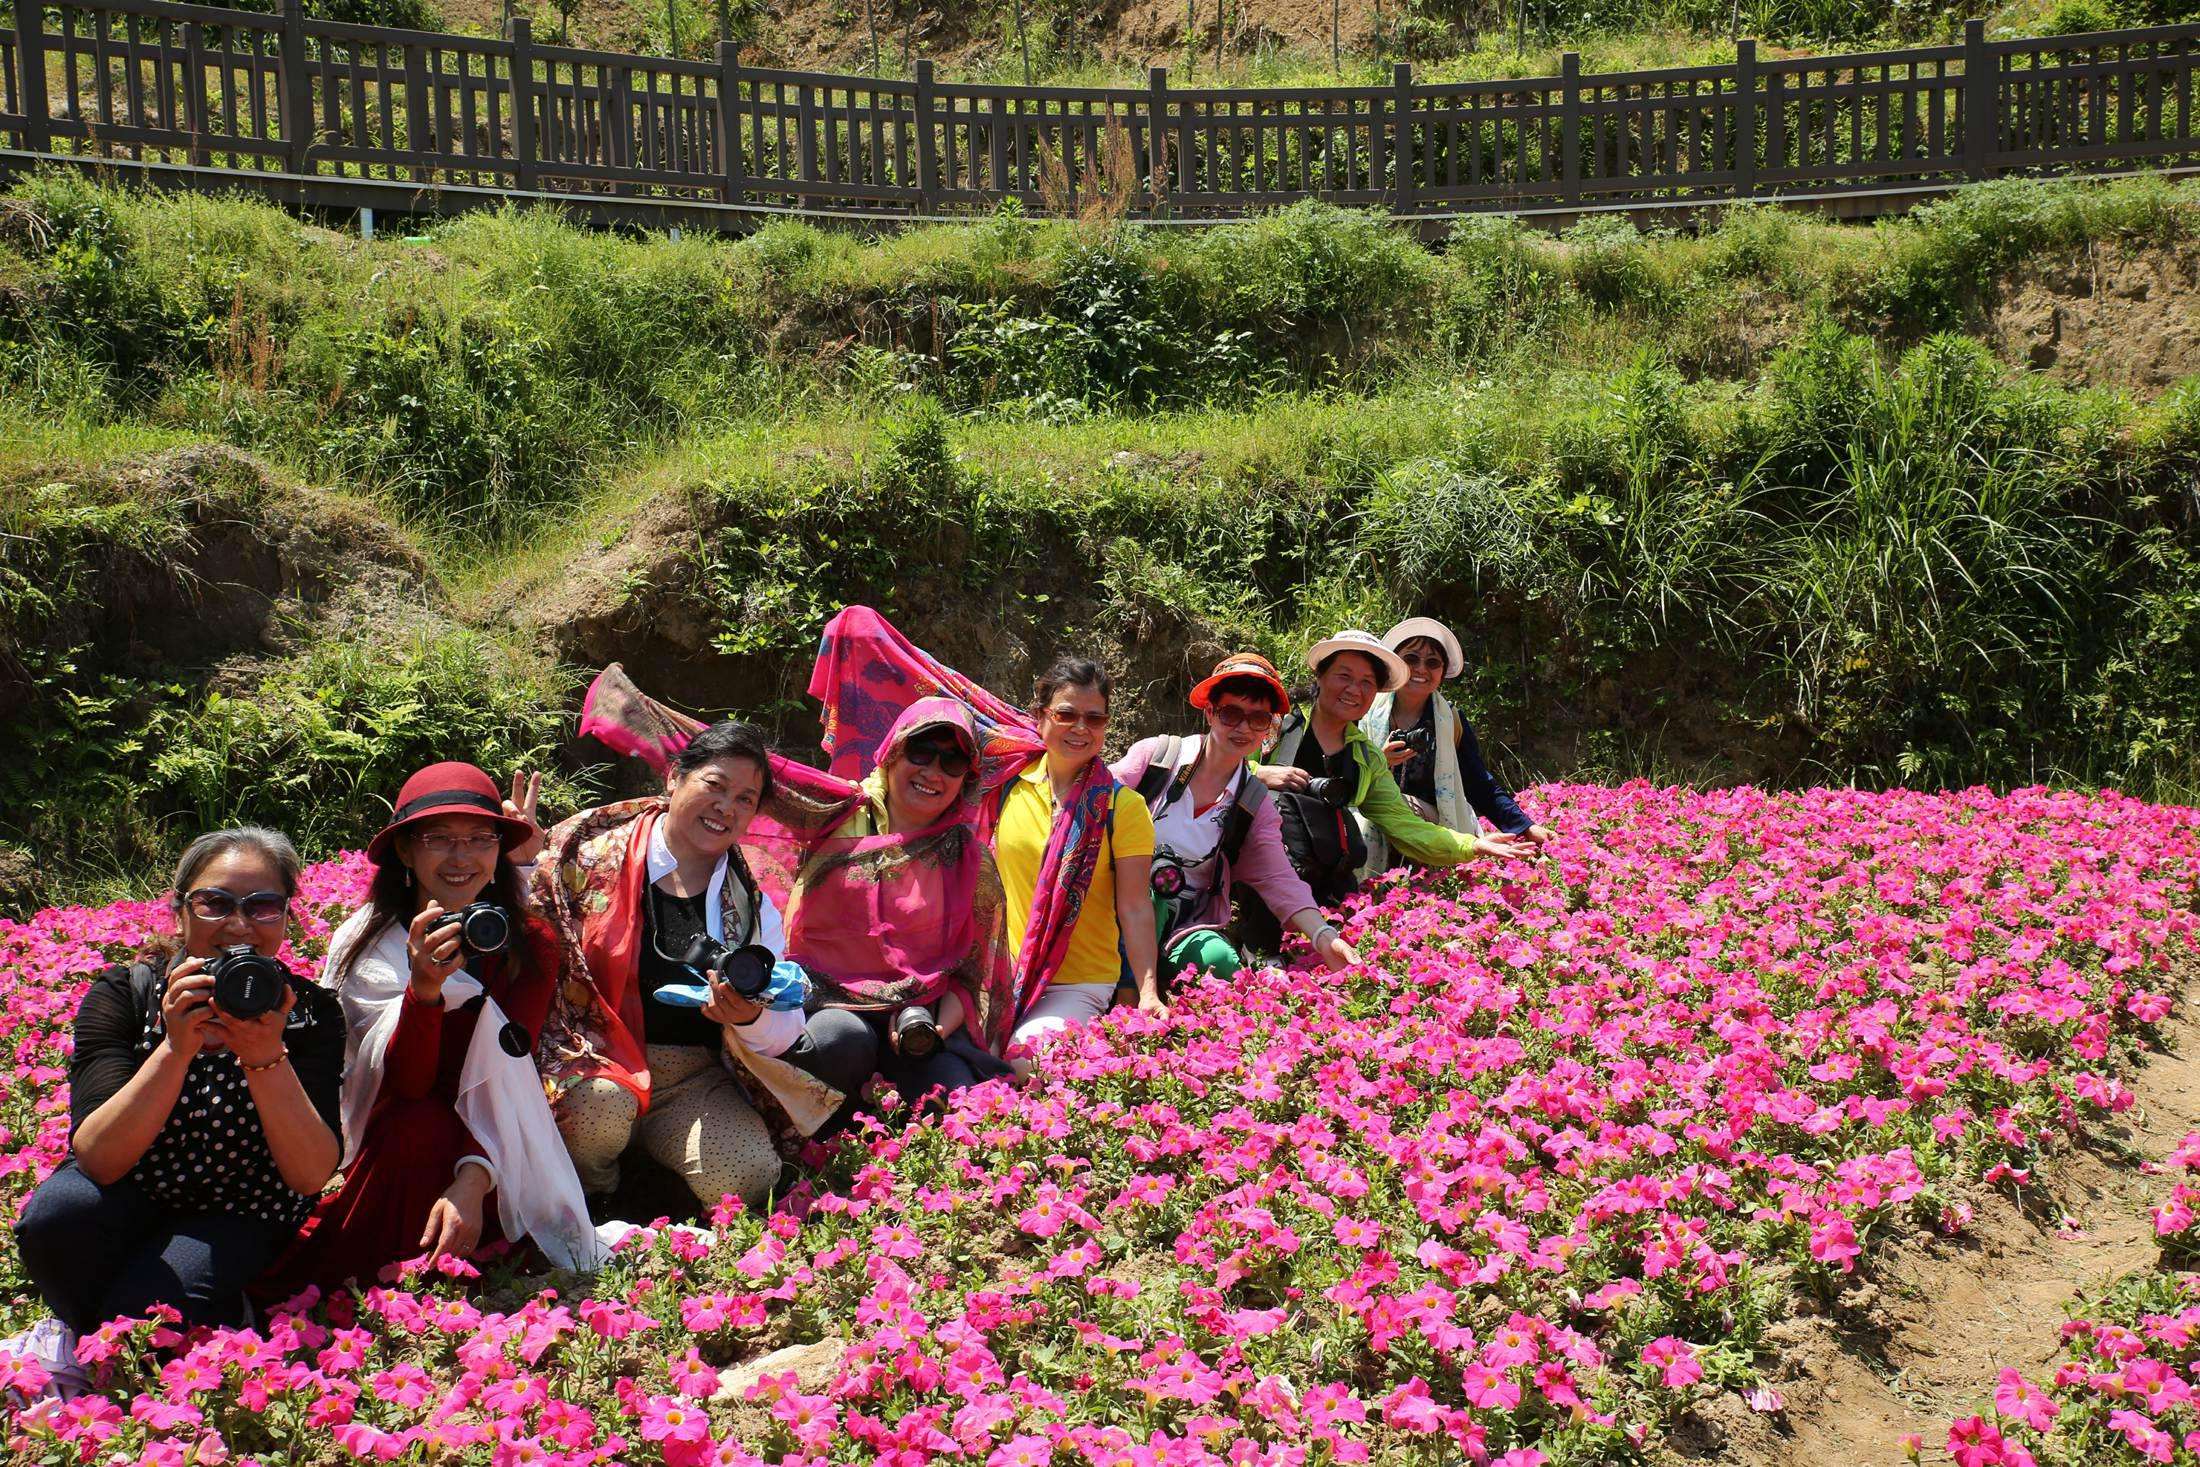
[1256,629,1536,919]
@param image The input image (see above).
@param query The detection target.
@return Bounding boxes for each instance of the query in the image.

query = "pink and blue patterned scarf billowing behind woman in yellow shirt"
[810,607,1120,1012]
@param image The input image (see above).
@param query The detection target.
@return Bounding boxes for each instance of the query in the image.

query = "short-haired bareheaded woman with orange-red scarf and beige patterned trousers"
[535,721,876,1207]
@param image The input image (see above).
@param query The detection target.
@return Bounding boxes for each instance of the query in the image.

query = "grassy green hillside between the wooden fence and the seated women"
[0,178,2200,902]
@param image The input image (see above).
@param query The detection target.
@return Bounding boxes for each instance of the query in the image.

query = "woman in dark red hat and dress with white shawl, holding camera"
[260,763,598,1298]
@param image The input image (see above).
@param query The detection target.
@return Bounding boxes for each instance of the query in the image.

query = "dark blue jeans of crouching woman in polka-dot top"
[15,1161,295,1335]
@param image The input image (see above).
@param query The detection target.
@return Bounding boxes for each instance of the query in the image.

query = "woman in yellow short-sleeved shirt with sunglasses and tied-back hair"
[992,658,1168,1043]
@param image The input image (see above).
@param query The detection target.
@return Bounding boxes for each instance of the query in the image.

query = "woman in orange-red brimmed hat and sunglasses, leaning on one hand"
[1115,651,1360,979]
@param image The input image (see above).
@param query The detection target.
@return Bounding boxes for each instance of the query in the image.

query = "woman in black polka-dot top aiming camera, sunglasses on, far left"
[15,827,343,1333]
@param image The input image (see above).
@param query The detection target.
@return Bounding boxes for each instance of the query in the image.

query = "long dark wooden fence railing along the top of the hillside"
[0,0,2200,218]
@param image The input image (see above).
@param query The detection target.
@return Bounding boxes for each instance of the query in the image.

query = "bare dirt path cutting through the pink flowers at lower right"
[1676,985,2200,1467]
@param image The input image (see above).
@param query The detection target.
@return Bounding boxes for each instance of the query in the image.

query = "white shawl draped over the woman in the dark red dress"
[321,908,603,1273]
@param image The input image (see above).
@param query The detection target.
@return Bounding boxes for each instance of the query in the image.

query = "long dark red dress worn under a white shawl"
[253,917,557,1302]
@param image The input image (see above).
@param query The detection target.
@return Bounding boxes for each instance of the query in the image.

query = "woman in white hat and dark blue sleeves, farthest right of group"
[1360,616,1551,875]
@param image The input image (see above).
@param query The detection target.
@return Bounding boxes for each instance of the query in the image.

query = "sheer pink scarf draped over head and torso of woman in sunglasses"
[581,664,1019,1056]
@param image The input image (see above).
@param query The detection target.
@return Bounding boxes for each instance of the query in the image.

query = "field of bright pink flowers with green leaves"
[0,785,2200,1467]
